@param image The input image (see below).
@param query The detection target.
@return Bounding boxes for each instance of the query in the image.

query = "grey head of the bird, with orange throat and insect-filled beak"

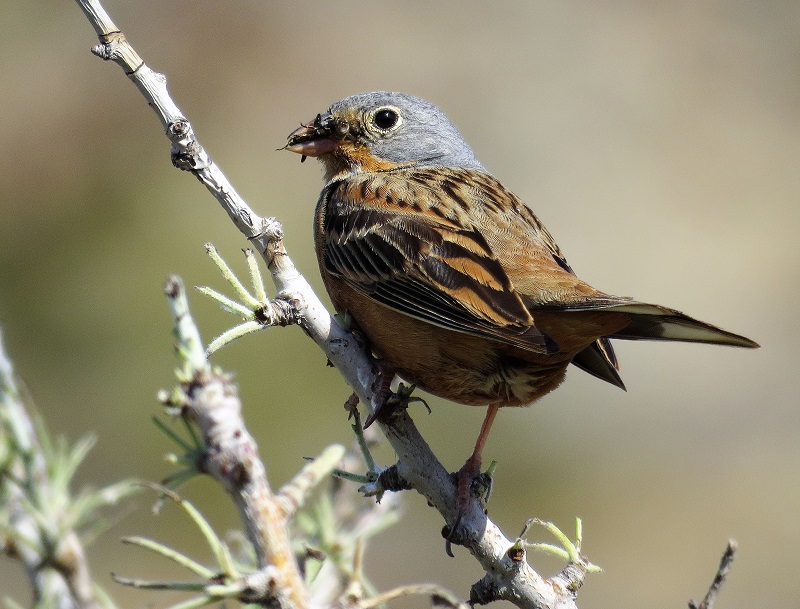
[286,91,485,177]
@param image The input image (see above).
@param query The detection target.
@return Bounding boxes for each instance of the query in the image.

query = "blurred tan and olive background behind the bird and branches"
[0,0,800,609]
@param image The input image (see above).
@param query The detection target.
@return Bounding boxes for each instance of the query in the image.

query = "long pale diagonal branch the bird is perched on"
[76,0,592,609]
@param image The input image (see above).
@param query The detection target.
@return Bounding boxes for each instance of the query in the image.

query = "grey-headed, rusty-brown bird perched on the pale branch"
[284,91,759,531]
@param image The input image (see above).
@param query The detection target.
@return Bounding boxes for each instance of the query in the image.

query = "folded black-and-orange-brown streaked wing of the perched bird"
[317,169,558,353]
